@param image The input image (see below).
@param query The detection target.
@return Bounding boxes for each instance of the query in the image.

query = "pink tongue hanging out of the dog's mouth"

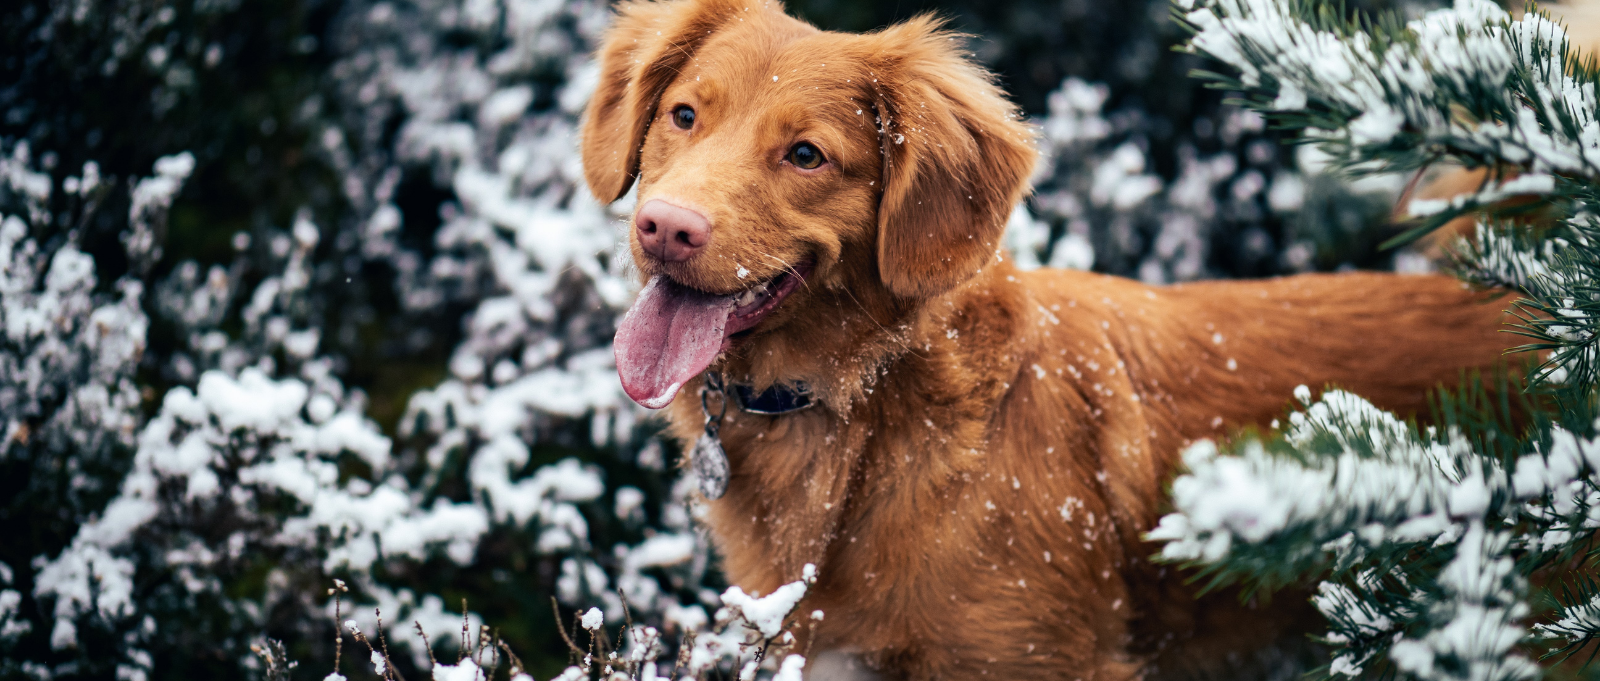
[614,275,733,409]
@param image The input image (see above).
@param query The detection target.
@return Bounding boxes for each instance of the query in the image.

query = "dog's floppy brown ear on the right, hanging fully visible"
[872,16,1038,297]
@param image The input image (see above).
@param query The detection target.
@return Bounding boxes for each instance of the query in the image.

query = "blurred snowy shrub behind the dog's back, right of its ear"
[1011,78,1427,283]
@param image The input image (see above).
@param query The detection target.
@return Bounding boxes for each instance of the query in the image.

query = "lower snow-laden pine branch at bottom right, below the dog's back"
[1149,379,1600,681]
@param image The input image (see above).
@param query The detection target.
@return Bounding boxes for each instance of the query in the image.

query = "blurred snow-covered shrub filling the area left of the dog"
[0,3,715,678]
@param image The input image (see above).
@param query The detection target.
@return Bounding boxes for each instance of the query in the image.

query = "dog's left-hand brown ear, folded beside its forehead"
[582,0,742,203]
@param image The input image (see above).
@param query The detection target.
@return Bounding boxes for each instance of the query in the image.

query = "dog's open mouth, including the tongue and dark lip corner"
[613,262,813,409]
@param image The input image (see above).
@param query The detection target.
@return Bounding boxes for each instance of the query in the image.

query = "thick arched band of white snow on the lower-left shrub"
[35,348,488,643]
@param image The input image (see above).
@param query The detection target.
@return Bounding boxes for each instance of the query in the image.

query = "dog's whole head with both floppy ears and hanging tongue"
[582,0,1035,408]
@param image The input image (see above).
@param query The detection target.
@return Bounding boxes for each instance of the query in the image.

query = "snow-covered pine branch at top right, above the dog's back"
[1181,0,1600,245]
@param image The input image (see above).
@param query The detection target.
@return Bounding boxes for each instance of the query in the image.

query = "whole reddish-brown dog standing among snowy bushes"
[582,0,1509,679]
